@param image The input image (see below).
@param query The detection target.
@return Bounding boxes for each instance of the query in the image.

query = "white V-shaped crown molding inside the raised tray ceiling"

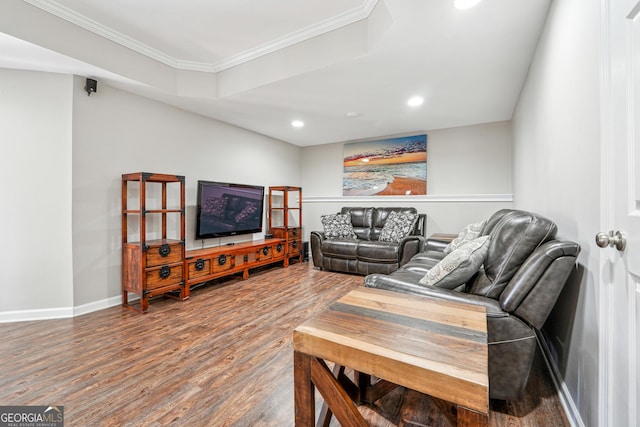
[24,0,379,72]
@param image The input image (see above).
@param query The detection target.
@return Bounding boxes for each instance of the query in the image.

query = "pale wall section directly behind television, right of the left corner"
[73,77,300,306]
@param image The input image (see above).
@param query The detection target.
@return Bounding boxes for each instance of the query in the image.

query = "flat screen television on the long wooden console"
[196,181,264,239]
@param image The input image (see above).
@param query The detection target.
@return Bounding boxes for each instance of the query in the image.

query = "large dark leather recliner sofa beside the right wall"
[365,209,580,401]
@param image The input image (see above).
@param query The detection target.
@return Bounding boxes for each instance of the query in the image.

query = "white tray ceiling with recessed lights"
[0,0,550,146]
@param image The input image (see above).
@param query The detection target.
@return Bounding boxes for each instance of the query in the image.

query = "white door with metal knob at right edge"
[594,0,640,427]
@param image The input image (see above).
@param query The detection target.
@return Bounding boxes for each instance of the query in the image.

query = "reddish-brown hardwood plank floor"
[0,263,569,427]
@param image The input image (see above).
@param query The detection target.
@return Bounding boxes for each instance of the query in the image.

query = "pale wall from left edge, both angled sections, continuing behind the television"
[0,69,300,321]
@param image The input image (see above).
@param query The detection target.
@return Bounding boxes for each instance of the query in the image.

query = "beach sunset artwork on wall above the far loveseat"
[342,134,427,196]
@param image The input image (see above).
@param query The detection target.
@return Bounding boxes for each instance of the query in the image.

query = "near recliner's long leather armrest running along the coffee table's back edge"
[364,272,509,317]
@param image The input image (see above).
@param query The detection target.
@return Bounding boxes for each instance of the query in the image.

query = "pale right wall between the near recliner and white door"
[513,0,600,426]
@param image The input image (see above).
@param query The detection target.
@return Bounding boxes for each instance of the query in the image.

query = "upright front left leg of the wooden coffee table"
[293,351,316,427]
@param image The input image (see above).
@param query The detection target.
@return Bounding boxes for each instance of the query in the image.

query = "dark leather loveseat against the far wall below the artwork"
[310,207,426,275]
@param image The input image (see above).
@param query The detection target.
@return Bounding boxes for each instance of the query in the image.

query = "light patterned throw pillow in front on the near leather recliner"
[419,235,489,289]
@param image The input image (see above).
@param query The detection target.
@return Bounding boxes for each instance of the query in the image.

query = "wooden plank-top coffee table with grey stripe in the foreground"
[293,288,489,427]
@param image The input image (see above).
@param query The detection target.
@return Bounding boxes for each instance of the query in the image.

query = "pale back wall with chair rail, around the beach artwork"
[302,122,512,238]
